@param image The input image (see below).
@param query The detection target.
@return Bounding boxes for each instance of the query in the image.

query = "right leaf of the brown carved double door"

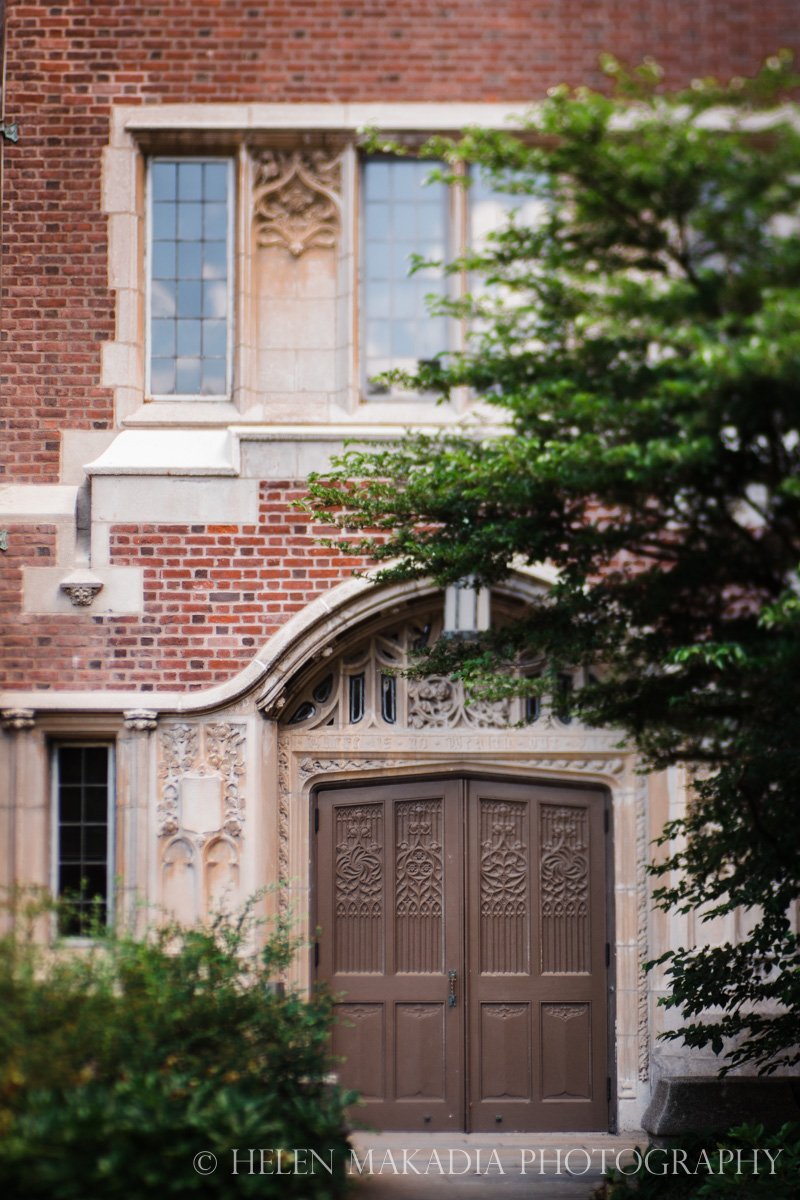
[467,780,608,1132]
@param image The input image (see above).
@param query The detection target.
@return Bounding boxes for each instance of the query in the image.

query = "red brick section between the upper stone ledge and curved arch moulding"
[0,482,367,691]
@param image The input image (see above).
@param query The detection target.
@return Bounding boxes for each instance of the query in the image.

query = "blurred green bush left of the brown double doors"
[0,906,353,1200]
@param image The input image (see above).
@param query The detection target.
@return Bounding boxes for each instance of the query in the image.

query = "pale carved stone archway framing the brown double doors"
[271,595,649,1128]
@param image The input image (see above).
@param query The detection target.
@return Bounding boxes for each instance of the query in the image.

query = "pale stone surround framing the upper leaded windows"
[102,103,527,428]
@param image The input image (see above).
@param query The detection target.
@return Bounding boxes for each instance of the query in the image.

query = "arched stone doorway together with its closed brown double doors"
[269,583,644,1130]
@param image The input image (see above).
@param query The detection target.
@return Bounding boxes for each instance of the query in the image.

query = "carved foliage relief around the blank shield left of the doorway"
[157,721,245,842]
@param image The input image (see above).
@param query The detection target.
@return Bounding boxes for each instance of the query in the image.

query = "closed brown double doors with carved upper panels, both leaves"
[315,778,608,1132]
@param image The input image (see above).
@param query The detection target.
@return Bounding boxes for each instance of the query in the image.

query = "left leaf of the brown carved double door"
[317,780,464,1129]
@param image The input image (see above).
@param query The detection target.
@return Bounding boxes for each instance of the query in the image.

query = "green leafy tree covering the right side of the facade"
[307,54,800,1072]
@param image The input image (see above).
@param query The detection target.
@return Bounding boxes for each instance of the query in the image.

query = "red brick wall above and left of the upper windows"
[0,0,800,481]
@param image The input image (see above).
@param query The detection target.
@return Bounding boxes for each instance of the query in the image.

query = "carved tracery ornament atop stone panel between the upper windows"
[254,150,342,258]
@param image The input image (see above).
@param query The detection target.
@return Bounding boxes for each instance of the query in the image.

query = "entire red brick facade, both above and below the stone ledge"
[0,0,798,690]
